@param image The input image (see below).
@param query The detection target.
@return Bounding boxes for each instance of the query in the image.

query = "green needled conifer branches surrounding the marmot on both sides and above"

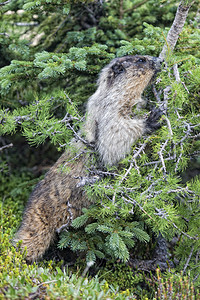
[0,0,200,299]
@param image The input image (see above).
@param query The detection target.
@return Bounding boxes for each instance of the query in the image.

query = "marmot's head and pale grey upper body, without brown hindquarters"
[85,55,161,165]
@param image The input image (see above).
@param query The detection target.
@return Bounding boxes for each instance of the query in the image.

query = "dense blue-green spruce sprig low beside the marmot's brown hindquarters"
[59,205,149,262]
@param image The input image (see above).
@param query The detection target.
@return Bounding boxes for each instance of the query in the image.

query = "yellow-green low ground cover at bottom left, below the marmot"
[0,172,134,300]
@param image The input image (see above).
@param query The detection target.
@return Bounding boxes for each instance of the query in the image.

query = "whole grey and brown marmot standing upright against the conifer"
[14,55,161,261]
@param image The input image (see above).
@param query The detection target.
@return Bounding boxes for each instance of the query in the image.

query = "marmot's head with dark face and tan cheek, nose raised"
[98,55,162,93]
